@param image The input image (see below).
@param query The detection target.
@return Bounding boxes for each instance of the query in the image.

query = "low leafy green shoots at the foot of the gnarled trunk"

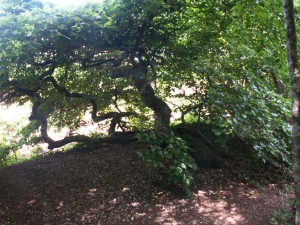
[137,131,198,198]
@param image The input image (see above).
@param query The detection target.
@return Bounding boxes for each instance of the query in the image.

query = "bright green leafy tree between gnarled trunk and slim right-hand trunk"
[185,0,291,163]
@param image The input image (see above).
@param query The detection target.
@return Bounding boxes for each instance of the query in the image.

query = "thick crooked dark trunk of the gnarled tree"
[111,65,171,134]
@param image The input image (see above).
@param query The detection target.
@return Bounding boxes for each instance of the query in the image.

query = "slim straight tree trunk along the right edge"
[283,0,300,225]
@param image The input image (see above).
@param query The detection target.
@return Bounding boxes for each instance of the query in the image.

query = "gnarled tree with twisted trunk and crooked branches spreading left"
[1,0,192,148]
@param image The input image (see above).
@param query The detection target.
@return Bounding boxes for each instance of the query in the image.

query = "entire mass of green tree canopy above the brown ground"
[0,0,300,174]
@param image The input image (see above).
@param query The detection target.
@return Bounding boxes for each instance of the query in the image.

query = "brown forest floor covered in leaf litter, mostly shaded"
[0,144,293,225]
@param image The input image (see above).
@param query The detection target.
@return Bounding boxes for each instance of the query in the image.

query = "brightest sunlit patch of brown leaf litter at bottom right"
[150,183,282,225]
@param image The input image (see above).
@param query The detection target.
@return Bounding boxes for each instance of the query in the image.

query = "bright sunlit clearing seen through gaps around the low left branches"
[0,103,108,161]
